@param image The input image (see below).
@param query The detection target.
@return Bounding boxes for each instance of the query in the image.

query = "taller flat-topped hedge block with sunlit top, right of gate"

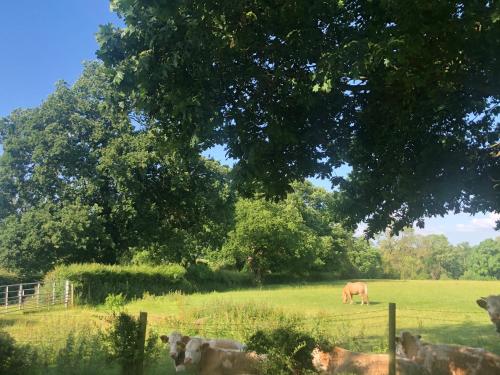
[44,263,193,304]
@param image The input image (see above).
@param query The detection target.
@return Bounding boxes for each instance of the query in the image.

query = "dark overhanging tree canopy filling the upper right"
[98,0,500,234]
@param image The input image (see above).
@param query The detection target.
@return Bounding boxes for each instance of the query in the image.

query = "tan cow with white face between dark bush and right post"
[312,347,429,375]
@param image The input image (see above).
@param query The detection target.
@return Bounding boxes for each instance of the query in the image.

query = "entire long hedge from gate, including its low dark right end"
[44,263,252,304]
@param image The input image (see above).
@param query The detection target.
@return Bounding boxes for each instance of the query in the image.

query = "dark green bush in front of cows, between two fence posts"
[247,327,317,375]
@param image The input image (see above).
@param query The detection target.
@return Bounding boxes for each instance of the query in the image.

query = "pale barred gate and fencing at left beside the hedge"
[0,280,74,314]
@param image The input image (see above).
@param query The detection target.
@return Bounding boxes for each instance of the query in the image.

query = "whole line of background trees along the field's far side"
[0,63,500,282]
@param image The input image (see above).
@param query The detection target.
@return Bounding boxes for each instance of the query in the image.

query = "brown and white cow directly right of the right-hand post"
[396,332,500,375]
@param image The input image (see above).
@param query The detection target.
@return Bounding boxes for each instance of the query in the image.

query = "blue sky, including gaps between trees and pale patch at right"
[0,0,500,244]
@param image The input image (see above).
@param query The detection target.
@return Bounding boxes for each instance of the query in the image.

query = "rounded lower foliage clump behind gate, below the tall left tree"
[0,202,110,276]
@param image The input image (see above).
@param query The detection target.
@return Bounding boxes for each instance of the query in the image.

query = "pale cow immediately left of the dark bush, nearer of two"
[184,338,265,375]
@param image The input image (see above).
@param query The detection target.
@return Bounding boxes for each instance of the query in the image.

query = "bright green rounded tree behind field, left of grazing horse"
[219,183,350,282]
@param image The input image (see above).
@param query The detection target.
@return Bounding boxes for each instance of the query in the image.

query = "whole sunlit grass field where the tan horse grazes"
[0,280,500,372]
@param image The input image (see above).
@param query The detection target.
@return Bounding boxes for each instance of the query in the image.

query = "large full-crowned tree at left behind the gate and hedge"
[0,63,234,274]
